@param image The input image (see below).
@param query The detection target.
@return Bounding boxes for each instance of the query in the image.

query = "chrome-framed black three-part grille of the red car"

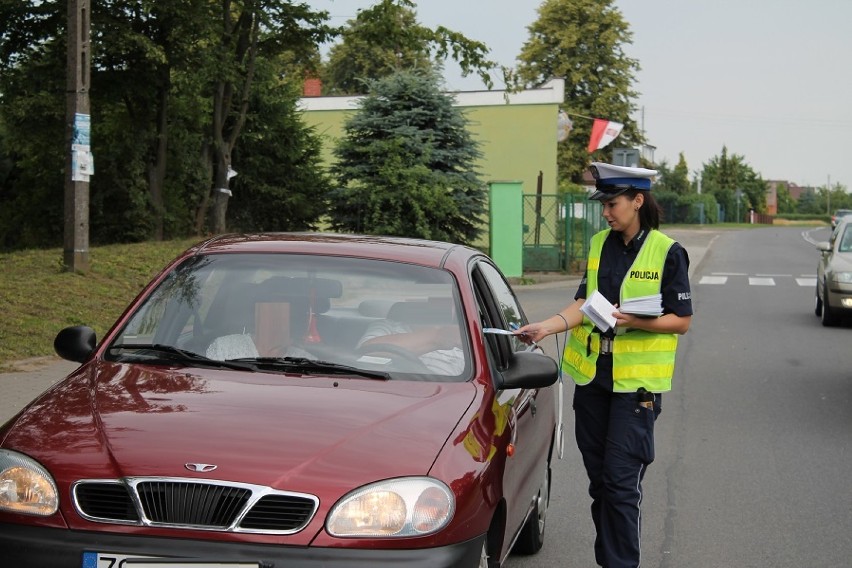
[72,478,319,534]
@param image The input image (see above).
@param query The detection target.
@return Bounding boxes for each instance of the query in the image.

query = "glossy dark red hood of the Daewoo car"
[3,362,477,492]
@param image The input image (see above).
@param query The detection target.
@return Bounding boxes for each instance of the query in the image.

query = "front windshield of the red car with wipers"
[106,254,471,381]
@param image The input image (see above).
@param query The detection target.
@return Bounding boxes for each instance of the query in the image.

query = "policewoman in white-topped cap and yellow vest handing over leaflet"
[516,162,692,568]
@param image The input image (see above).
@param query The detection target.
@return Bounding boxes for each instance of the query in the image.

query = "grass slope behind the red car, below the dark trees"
[0,238,200,370]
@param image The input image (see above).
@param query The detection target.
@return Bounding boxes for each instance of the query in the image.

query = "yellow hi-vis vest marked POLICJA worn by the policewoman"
[562,229,677,392]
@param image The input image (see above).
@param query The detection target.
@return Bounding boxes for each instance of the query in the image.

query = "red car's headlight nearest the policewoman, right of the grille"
[326,477,455,537]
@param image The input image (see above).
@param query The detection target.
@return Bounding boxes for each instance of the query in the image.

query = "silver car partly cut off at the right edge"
[815,215,852,326]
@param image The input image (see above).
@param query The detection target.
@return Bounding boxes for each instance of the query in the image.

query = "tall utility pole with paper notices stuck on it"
[63,0,94,272]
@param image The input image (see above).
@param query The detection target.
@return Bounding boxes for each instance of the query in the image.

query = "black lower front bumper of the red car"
[0,523,485,568]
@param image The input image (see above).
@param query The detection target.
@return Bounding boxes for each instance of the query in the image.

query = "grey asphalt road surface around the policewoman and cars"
[0,226,852,568]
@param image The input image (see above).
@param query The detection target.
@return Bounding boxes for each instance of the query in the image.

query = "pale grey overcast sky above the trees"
[307,0,852,191]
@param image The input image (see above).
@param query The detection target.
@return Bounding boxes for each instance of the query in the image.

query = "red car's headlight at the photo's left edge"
[0,450,59,517]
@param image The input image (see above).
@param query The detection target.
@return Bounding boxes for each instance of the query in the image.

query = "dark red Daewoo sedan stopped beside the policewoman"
[0,234,561,568]
